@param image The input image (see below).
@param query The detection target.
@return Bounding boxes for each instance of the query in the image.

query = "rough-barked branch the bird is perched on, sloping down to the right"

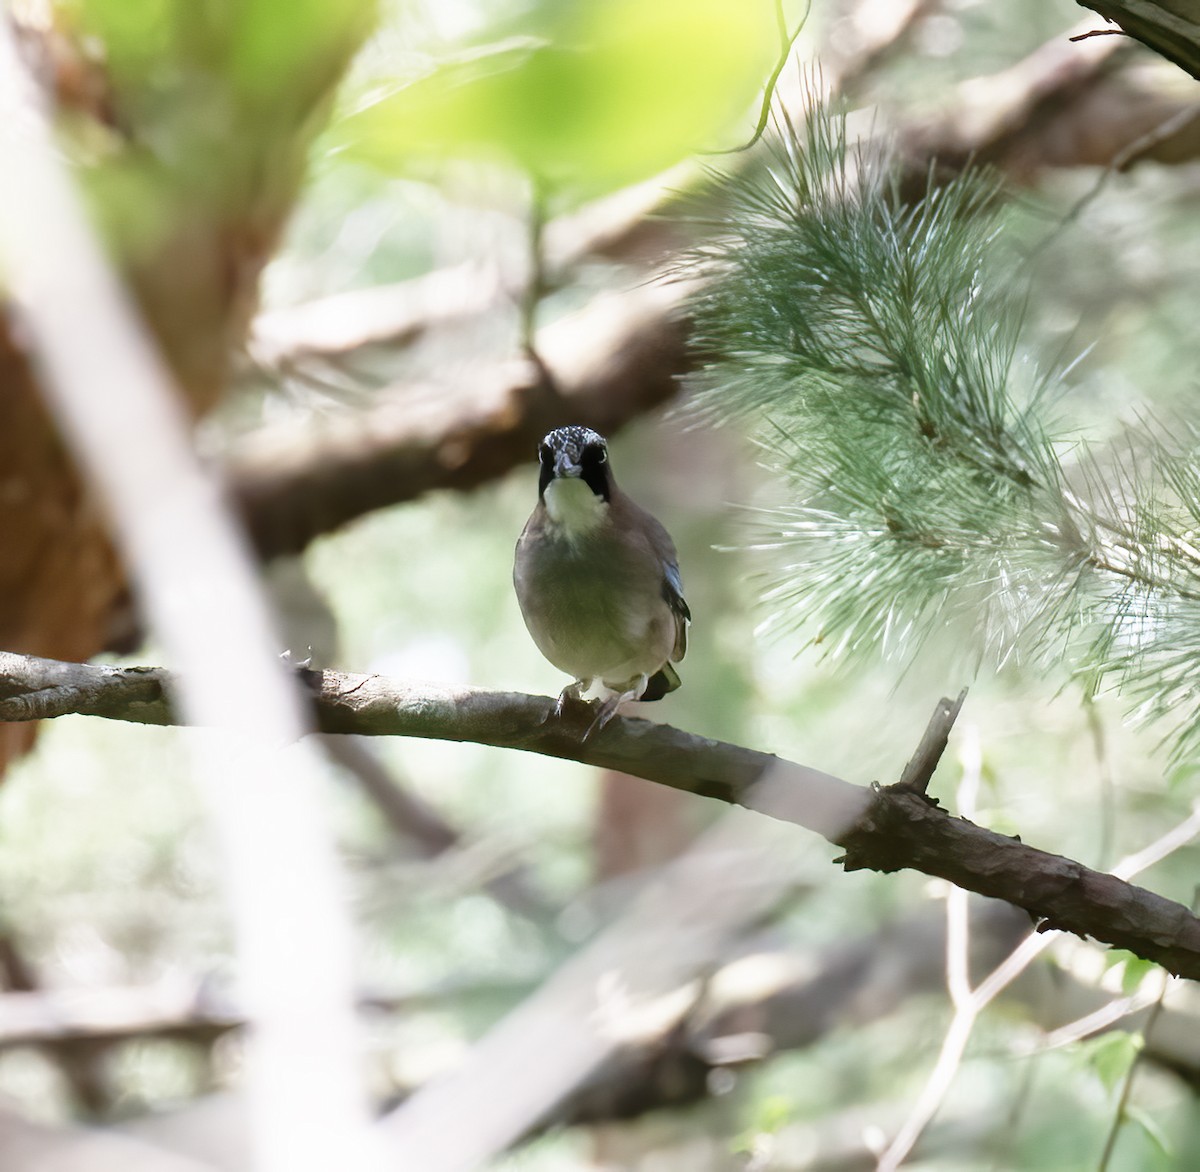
[7,653,1200,979]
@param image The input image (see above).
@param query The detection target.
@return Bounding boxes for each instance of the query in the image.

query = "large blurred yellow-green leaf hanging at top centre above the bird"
[340,0,774,191]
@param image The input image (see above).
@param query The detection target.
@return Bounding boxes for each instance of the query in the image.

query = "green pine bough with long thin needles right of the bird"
[695,110,1200,751]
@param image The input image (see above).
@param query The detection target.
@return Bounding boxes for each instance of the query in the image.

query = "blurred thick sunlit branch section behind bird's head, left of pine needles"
[228,283,691,558]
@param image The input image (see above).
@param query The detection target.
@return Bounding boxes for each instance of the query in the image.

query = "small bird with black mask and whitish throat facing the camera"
[512,426,691,739]
